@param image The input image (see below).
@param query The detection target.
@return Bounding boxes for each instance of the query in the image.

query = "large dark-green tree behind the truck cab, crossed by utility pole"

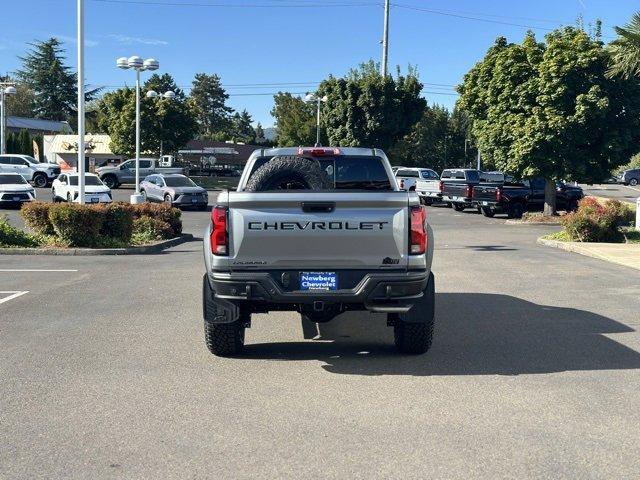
[318,61,426,149]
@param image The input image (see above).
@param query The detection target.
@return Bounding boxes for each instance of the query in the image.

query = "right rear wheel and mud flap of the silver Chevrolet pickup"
[393,273,435,355]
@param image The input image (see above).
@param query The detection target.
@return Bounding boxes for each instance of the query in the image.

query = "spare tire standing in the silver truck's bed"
[244,155,333,192]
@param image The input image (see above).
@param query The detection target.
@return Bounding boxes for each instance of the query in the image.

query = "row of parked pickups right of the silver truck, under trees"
[395,167,584,218]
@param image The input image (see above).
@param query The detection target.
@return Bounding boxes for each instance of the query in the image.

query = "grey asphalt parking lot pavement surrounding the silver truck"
[0,194,640,479]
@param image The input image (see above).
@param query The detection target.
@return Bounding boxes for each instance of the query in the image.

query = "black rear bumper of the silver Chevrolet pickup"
[208,270,429,313]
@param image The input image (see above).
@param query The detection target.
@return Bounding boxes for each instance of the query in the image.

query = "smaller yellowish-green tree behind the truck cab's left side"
[271,92,316,147]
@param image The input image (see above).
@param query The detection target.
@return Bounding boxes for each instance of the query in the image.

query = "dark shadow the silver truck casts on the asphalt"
[243,293,640,375]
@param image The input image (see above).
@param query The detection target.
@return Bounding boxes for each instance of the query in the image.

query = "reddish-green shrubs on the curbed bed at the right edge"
[562,197,634,242]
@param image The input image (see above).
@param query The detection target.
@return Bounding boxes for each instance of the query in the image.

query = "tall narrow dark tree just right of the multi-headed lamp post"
[189,73,233,137]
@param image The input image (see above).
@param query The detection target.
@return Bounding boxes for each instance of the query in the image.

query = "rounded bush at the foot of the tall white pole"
[49,203,105,247]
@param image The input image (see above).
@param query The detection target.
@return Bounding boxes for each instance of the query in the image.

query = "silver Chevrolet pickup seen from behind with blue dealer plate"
[203,147,435,356]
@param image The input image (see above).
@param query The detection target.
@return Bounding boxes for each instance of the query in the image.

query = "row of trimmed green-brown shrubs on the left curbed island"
[21,202,182,247]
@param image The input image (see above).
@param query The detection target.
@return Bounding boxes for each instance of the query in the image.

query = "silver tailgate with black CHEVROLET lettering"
[228,190,409,271]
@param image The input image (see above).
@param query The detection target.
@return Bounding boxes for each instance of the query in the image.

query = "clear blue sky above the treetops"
[0,0,640,127]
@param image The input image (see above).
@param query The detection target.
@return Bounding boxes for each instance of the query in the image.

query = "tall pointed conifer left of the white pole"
[17,38,99,123]
